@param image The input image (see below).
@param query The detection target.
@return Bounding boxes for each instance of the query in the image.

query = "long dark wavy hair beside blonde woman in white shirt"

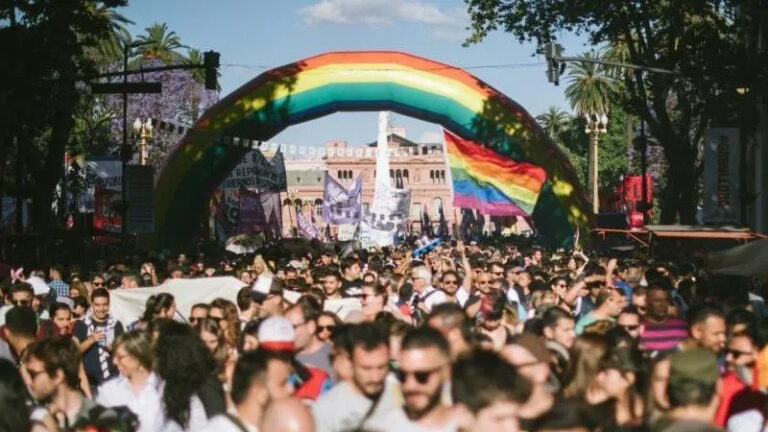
[155,321,216,428]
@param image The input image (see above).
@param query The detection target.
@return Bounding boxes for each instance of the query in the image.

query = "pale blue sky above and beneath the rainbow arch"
[121,0,588,145]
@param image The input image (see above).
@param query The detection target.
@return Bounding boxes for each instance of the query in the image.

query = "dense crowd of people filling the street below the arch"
[0,241,768,432]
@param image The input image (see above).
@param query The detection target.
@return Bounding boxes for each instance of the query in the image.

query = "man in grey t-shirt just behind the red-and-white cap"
[285,296,333,376]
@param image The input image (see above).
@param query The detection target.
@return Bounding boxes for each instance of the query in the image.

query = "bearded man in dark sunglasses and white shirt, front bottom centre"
[370,327,458,432]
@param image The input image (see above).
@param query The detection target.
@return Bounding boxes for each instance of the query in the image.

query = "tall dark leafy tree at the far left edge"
[0,0,126,230]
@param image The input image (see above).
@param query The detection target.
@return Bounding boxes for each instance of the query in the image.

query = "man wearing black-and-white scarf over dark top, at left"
[72,288,123,387]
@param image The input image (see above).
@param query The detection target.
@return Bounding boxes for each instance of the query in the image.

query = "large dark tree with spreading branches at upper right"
[466,0,768,223]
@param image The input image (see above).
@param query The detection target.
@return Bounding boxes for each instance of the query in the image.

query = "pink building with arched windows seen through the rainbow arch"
[282,129,459,233]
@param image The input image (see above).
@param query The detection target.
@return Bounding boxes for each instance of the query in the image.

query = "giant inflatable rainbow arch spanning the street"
[155,51,592,250]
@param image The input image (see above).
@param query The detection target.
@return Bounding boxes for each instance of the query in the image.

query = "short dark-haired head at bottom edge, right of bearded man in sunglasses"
[451,350,531,432]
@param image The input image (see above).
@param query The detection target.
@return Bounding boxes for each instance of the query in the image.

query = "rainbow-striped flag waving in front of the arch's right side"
[443,130,547,216]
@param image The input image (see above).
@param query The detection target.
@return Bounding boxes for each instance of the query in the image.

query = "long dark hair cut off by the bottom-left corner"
[0,359,32,432]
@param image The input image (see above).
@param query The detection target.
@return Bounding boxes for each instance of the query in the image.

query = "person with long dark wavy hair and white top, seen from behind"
[155,321,226,431]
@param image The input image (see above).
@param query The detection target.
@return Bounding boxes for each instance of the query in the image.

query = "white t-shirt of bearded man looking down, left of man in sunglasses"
[312,377,399,432]
